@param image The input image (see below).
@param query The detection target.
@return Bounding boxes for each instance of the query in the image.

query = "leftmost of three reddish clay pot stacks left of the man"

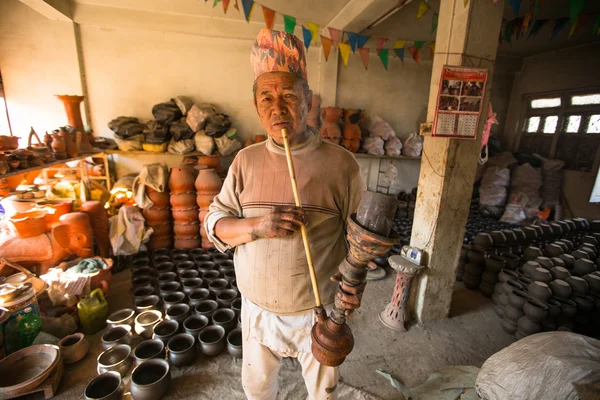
[142,186,173,250]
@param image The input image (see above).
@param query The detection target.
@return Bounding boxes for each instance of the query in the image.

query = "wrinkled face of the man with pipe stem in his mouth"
[254,72,312,145]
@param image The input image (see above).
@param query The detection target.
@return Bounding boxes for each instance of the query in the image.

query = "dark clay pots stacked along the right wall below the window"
[482,218,600,339]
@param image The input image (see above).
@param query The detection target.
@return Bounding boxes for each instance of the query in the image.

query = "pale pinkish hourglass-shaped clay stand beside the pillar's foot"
[379,256,423,332]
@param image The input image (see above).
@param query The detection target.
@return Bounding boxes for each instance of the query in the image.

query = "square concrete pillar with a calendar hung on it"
[411,0,504,322]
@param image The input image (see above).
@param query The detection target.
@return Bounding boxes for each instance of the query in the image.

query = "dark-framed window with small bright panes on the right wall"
[518,89,600,171]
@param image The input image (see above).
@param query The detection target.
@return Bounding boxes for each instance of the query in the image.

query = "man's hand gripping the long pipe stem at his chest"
[252,206,306,240]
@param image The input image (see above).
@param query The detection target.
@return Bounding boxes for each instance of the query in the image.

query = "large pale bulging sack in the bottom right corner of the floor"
[475,332,600,400]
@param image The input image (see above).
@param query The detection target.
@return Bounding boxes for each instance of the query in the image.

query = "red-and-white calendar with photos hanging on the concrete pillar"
[433,65,488,139]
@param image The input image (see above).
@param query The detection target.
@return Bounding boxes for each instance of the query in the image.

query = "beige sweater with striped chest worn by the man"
[205,134,365,314]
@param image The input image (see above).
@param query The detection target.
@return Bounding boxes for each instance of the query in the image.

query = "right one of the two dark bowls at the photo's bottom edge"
[130,359,171,400]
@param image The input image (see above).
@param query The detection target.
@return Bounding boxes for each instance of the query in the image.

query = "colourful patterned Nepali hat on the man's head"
[250,29,308,80]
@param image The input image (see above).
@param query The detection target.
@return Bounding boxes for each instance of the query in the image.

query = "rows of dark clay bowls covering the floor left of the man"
[85,248,242,400]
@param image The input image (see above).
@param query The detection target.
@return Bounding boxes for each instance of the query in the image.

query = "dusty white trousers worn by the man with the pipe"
[242,308,339,400]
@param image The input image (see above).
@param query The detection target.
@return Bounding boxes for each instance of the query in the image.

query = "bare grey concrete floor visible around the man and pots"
[56,271,514,400]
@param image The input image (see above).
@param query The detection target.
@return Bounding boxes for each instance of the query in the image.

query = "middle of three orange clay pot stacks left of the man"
[169,167,201,249]
